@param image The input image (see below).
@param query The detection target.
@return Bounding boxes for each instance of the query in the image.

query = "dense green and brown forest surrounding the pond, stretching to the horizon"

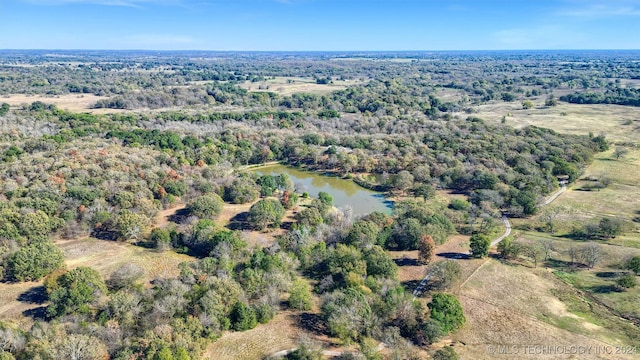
[0,51,640,359]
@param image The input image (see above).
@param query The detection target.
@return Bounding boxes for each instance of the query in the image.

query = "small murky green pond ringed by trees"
[250,165,392,217]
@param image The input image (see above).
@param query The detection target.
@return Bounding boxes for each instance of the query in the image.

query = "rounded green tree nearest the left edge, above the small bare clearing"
[7,241,64,281]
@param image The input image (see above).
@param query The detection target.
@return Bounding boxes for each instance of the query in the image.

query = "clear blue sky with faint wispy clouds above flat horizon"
[0,0,640,51]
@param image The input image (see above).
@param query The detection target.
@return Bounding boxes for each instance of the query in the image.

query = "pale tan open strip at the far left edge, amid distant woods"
[0,94,125,114]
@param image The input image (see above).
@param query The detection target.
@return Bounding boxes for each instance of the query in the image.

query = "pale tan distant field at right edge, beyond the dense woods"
[457,97,640,144]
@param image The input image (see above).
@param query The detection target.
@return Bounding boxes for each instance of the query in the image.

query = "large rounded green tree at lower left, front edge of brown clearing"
[47,267,107,316]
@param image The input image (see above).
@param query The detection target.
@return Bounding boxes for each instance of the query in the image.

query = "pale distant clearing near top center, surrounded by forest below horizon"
[240,77,357,95]
